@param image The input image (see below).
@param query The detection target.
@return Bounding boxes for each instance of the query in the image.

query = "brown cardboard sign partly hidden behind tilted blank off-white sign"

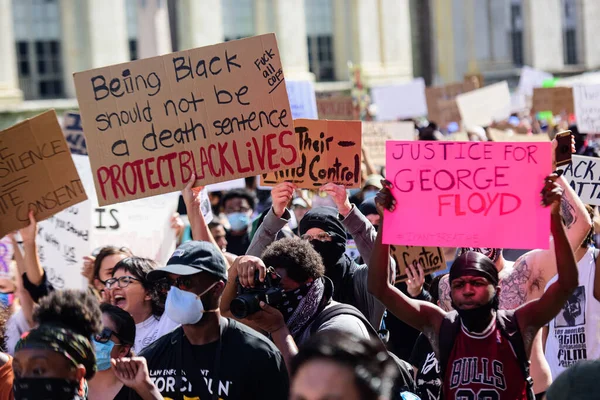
[425,80,478,127]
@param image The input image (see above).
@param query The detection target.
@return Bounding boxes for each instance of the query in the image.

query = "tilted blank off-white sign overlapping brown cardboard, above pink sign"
[456,81,511,126]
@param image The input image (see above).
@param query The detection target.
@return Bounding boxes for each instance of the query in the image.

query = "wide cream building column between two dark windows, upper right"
[523,0,564,72]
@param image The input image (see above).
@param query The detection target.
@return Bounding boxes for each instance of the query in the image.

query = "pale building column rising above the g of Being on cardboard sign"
[136,0,173,58]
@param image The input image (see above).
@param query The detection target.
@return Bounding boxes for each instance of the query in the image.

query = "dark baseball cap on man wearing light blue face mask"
[148,241,227,281]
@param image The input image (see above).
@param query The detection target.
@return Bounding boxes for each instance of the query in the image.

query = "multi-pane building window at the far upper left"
[13,0,65,100]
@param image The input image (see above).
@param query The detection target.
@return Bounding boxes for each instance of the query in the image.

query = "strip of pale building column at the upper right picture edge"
[580,0,600,69]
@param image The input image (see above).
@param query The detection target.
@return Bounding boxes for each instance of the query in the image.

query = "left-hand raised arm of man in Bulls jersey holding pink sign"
[368,181,445,332]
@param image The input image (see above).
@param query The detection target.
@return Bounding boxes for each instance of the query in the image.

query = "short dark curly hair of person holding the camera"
[261,238,325,283]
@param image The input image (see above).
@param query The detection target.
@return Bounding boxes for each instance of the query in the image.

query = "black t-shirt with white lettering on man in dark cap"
[132,320,289,400]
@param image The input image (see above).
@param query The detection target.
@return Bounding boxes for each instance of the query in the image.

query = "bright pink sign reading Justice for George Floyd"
[383,141,552,249]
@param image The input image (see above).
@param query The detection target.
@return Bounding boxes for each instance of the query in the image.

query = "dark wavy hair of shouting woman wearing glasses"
[113,256,167,318]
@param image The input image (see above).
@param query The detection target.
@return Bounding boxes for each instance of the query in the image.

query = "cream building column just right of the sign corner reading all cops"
[274,0,315,81]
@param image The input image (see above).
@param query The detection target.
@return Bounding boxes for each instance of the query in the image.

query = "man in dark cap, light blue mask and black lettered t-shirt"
[134,241,289,400]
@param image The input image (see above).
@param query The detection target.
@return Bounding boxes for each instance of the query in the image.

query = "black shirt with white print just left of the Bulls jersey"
[410,334,442,400]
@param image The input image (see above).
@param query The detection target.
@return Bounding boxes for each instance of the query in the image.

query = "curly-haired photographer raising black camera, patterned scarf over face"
[222,238,376,367]
